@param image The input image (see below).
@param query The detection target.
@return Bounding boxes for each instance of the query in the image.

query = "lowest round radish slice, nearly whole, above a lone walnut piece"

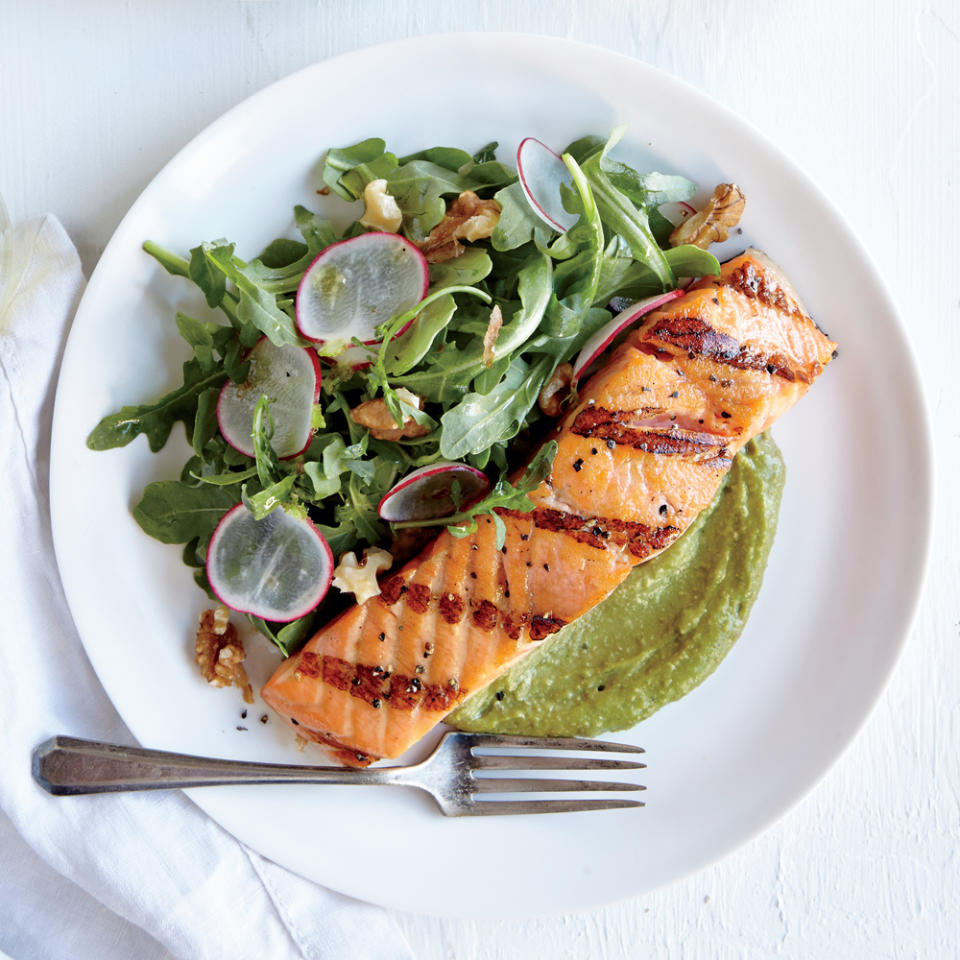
[207,503,333,623]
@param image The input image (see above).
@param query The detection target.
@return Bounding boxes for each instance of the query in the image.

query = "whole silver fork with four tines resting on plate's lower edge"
[33,731,646,817]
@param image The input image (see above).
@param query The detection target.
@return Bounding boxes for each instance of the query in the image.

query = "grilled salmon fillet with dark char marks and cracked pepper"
[262,250,836,765]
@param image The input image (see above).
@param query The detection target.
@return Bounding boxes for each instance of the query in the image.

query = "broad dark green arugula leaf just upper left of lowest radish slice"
[133,480,239,543]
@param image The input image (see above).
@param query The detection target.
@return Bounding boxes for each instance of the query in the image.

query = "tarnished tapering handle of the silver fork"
[33,737,404,796]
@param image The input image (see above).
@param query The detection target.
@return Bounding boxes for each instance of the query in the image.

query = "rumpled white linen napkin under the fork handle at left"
[0,214,412,960]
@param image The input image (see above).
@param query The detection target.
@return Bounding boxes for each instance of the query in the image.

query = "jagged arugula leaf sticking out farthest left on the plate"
[87,360,227,453]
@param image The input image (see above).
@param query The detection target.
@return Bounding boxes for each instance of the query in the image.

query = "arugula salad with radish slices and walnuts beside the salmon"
[87,130,719,655]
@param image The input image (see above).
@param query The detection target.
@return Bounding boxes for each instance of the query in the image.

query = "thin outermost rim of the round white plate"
[49,31,937,918]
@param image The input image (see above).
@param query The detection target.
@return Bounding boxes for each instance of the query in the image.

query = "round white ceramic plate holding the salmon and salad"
[51,34,930,916]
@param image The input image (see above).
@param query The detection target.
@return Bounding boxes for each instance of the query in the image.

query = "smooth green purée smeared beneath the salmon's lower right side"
[447,434,784,736]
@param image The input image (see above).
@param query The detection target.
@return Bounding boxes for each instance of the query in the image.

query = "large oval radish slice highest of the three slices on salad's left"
[297,230,430,343]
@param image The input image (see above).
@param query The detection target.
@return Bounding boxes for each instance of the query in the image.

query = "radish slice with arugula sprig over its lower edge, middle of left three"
[217,337,320,460]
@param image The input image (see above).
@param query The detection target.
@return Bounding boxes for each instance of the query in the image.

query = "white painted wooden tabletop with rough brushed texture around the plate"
[0,0,960,960]
